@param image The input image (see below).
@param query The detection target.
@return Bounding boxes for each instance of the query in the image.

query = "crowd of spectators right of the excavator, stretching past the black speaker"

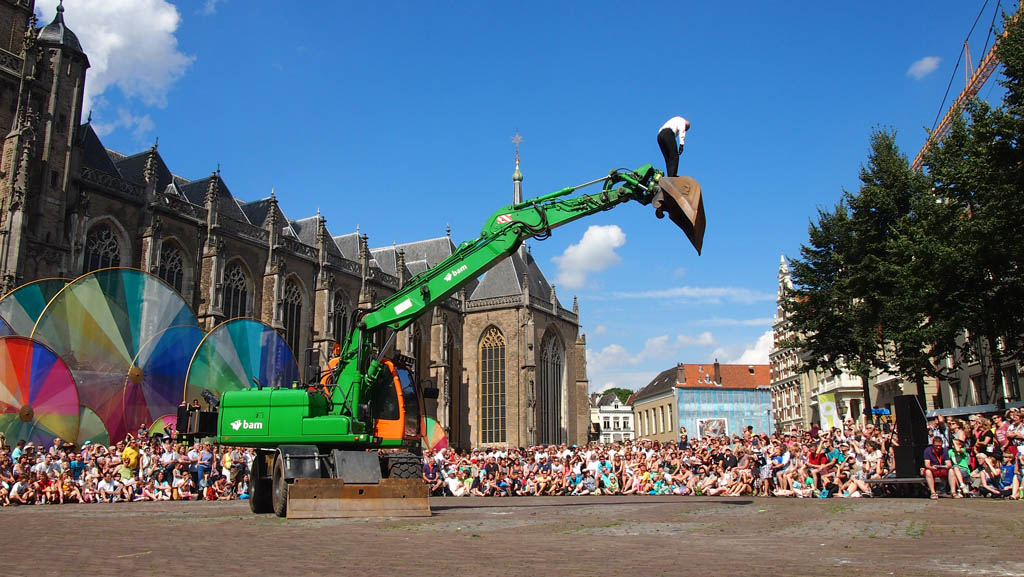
[423,410,1024,499]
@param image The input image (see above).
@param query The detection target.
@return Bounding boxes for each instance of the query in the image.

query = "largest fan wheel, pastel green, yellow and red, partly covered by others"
[32,269,199,441]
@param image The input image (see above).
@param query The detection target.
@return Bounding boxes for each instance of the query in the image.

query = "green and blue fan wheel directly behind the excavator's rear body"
[184,319,299,402]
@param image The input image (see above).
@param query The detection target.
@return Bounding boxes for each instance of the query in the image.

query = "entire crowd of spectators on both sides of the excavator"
[0,409,1024,506]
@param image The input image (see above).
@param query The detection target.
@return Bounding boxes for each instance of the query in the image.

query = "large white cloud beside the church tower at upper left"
[36,0,194,131]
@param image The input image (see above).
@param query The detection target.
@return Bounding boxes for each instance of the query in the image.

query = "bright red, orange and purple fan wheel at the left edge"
[0,336,79,447]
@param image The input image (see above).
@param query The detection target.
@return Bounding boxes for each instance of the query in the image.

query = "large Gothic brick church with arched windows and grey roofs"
[0,0,589,447]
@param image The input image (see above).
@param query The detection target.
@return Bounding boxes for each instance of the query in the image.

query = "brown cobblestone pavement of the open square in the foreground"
[0,497,1024,577]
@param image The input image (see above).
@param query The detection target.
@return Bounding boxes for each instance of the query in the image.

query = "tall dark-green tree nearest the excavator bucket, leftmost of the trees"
[785,130,929,414]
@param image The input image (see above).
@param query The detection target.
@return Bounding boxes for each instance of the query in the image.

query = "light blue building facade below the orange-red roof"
[675,386,774,439]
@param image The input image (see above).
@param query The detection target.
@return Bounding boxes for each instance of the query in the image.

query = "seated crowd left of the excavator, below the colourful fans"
[0,424,253,506]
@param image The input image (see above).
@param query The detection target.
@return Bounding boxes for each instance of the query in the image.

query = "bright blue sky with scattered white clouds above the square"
[37,0,1013,390]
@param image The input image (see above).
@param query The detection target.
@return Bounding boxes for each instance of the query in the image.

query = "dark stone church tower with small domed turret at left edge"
[0,2,89,290]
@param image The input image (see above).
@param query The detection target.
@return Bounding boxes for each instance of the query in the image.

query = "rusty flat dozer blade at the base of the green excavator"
[288,479,430,519]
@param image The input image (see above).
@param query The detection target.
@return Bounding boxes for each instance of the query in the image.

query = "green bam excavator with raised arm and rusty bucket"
[185,165,706,519]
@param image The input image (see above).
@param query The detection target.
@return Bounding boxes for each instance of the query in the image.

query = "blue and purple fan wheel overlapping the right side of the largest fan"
[122,326,203,430]
